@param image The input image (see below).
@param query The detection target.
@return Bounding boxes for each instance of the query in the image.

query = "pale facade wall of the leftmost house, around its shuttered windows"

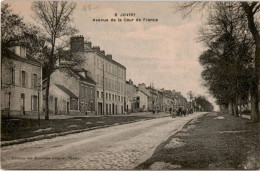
[1,60,42,116]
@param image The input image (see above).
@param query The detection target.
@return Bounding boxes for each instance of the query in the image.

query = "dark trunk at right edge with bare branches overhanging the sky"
[177,2,260,122]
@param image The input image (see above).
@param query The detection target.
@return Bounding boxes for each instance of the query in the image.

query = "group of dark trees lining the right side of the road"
[179,2,260,122]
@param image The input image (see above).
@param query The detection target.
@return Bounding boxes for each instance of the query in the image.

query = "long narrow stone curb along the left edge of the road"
[1,115,170,147]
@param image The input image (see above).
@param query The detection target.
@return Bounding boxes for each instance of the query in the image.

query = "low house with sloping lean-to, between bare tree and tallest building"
[44,69,96,115]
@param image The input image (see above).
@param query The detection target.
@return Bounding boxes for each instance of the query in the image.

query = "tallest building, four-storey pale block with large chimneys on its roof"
[70,36,126,115]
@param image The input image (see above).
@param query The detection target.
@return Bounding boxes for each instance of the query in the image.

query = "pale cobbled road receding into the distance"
[1,113,206,170]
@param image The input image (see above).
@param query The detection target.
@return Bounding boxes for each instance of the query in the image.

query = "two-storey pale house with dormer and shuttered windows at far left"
[1,46,42,117]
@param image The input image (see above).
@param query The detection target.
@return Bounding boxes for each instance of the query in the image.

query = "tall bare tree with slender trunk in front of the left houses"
[32,1,84,120]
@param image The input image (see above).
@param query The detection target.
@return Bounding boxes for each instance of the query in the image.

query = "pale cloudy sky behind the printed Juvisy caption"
[6,1,218,110]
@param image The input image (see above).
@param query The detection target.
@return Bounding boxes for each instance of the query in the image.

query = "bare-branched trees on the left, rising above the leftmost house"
[1,1,84,120]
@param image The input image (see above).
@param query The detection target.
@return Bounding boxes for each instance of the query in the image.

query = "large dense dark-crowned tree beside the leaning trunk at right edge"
[200,3,254,116]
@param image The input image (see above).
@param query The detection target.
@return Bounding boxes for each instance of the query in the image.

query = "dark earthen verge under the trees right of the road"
[136,113,260,170]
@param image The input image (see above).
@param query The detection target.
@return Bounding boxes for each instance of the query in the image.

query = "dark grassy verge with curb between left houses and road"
[1,112,170,146]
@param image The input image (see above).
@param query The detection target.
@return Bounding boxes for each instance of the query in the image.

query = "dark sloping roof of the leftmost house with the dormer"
[6,50,43,67]
